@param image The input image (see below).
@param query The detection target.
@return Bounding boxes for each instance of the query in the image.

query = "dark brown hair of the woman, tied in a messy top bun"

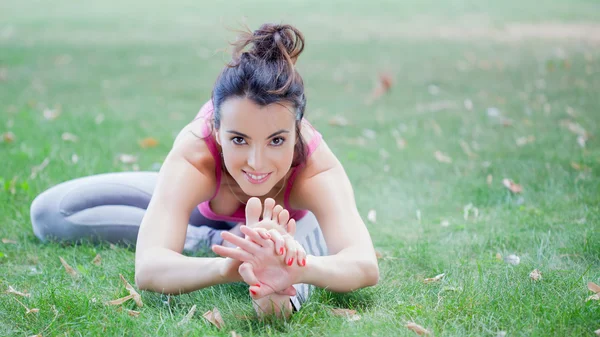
[212,23,306,166]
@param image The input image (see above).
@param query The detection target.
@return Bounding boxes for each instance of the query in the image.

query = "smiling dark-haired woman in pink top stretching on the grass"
[31,24,379,314]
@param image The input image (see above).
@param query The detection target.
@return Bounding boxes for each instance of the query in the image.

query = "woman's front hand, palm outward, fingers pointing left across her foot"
[213,226,304,299]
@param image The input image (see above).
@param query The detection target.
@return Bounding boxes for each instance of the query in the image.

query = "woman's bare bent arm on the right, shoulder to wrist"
[297,144,379,292]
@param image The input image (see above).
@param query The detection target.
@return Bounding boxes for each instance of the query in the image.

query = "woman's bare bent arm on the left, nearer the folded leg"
[135,122,241,294]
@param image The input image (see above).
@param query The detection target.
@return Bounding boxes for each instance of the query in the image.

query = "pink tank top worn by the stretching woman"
[195,100,322,222]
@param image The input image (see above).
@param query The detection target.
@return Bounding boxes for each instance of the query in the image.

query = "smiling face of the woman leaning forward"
[216,98,296,196]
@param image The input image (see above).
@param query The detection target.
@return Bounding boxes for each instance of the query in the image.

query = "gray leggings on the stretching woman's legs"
[31,172,327,309]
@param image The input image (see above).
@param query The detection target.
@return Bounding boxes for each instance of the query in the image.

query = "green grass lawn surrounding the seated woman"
[0,0,600,336]
